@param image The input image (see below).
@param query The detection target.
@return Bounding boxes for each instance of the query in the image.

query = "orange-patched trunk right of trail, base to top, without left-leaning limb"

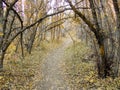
[89,0,111,78]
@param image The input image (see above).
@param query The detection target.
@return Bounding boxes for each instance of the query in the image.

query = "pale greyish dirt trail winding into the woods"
[37,39,72,90]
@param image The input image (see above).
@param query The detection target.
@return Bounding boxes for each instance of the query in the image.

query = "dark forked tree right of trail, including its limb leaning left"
[67,0,118,78]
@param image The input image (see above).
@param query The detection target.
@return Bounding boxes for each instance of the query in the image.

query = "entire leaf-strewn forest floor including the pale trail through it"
[0,38,120,90]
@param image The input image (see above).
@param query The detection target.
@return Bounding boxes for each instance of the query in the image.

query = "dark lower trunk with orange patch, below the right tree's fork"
[97,39,111,78]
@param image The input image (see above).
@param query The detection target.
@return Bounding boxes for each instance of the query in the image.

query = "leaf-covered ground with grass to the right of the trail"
[64,42,120,90]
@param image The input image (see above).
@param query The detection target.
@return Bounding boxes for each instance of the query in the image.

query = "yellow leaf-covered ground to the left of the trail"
[0,41,58,90]
